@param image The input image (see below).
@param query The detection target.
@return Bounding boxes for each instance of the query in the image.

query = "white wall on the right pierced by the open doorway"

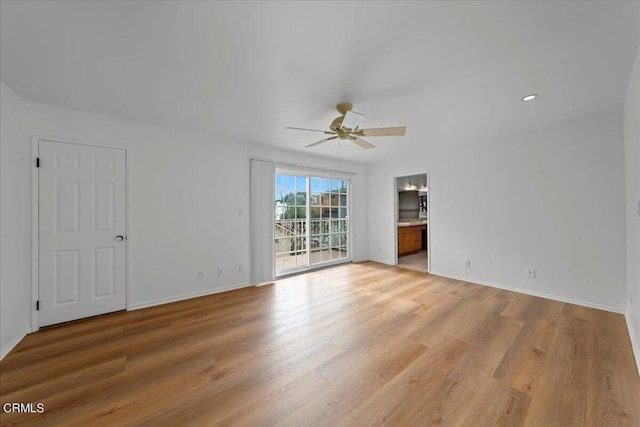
[369,114,625,311]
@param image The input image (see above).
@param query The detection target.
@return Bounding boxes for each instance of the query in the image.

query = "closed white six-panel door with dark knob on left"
[38,141,126,326]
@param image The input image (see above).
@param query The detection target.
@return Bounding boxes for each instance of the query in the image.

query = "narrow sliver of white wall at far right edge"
[624,49,640,372]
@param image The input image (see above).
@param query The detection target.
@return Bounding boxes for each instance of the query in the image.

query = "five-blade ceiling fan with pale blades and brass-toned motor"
[286,102,407,148]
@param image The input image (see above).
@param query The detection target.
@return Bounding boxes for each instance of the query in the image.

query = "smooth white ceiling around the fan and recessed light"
[0,0,640,163]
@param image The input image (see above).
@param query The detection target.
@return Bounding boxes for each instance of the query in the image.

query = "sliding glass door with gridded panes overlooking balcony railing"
[274,173,351,276]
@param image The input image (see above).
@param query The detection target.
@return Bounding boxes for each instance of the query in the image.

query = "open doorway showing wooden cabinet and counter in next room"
[394,172,430,273]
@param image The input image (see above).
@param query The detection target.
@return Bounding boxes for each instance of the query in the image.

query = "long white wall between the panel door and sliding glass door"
[27,103,368,308]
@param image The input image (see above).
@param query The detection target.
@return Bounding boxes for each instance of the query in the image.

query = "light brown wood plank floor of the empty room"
[0,262,640,427]
